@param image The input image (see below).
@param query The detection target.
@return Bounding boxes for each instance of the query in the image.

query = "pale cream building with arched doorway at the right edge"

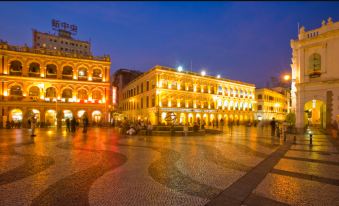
[291,18,339,129]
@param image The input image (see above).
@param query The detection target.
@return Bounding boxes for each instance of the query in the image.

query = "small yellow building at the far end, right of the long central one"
[255,88,289,121]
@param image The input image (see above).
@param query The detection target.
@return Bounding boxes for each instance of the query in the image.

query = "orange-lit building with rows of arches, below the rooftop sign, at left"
[0,42,111,125]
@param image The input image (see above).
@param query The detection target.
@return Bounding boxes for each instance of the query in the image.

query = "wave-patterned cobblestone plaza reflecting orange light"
[0,126,339,206]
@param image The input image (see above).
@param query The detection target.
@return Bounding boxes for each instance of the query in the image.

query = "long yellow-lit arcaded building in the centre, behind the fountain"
[119,66,255,124]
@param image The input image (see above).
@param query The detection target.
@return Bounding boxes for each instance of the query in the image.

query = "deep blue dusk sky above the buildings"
[0,2,339,87]
